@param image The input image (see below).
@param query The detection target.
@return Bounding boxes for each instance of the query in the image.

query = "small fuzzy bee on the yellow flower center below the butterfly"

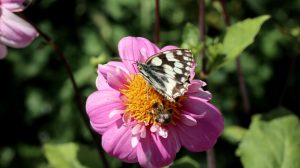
[150,103,173,124]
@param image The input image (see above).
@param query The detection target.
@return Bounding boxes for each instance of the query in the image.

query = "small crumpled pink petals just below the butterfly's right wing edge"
[186,80,212,101]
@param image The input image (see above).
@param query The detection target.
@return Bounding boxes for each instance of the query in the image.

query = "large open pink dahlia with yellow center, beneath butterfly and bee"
[86,37,224,167]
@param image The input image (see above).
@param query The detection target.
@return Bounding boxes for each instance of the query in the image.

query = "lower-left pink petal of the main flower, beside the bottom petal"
[102,121,137,163]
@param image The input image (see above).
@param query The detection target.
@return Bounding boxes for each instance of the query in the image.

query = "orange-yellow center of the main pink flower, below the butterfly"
[121,74,180,125]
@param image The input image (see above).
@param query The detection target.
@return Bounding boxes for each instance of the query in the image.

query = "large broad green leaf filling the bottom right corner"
[236,108,300,168]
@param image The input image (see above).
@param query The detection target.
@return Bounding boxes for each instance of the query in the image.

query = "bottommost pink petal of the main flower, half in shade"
[137,131,180,168]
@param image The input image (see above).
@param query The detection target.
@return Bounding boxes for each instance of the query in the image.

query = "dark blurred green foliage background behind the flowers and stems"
[0,0,300,168]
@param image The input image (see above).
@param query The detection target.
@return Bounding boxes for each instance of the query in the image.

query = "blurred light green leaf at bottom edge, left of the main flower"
[44,143,87,168]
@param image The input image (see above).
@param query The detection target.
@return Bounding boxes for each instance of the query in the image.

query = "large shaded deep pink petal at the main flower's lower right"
[177,97,224,152]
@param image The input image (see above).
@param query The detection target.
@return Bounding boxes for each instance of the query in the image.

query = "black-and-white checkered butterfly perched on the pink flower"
[137,49,194,102]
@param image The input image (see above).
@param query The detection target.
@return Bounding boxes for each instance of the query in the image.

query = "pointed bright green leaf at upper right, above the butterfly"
[223,15,270,62]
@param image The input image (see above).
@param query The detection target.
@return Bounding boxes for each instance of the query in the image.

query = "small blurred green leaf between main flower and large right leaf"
[222,126,247,144]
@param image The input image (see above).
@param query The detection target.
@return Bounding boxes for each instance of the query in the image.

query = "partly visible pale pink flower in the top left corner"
[0,0,38,59]
